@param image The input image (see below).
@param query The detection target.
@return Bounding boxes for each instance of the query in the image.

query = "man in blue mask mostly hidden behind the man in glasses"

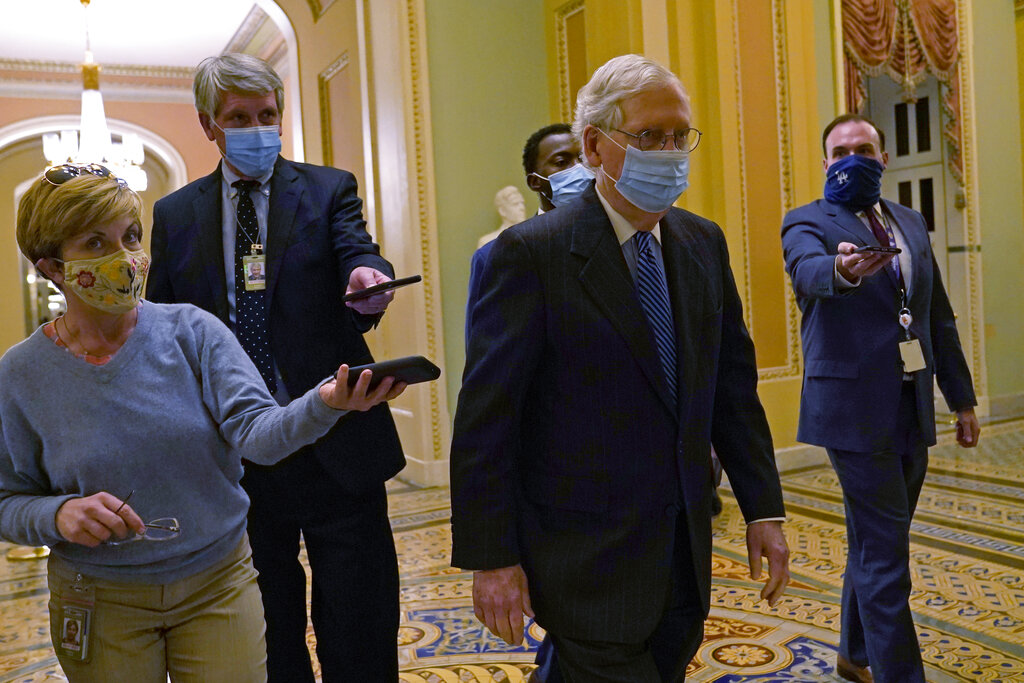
[466,123,594,339]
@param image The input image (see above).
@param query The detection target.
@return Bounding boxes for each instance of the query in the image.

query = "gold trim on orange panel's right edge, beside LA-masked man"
[758,0,806,380]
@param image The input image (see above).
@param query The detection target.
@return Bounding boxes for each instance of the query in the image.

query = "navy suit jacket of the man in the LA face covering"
[782,200,976,453]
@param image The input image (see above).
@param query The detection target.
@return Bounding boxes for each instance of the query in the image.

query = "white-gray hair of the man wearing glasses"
[572,54,689,165]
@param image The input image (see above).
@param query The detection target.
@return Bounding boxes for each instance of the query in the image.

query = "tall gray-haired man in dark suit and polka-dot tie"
[146,54,404,683]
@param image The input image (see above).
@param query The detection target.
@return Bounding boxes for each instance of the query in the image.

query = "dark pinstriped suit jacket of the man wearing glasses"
[452,187,783,642]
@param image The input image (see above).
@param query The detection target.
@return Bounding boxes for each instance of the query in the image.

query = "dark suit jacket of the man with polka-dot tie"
[146,157,404,493]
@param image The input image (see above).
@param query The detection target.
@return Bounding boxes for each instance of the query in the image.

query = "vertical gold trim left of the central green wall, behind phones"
[406,0,447,459]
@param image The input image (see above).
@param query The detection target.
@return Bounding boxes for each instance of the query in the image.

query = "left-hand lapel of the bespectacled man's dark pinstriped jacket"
[569,188,676,416]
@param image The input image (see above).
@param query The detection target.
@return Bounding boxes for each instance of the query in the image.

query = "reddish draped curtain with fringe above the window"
[843,0,964,185]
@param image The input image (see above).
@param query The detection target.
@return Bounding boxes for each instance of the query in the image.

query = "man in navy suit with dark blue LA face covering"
[782,115,980,683]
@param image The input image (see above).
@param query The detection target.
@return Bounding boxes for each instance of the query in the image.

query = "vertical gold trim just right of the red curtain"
[956,0,987,403]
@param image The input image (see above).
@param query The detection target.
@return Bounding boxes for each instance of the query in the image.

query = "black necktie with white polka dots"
[231,180,278,393]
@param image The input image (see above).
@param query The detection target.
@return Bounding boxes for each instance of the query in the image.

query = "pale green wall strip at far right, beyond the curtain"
[969,0,1024,407]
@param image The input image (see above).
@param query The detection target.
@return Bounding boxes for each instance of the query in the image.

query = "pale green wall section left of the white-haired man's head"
[426,0,552,412]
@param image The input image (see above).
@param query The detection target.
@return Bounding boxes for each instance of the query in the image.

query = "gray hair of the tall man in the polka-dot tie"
[193,52,285,119]
